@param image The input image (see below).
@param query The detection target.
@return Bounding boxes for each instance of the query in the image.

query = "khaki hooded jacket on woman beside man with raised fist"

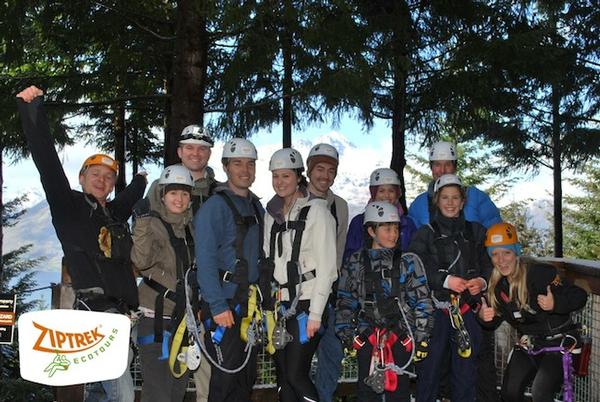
[131,185,194,316]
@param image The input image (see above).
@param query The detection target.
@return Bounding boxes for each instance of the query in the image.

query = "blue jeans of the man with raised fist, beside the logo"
[83,348,135,402]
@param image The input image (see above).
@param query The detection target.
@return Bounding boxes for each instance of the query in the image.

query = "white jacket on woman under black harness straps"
[264,195,337,321]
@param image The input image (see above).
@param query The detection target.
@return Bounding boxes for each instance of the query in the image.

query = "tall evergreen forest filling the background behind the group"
[0,0,600,398]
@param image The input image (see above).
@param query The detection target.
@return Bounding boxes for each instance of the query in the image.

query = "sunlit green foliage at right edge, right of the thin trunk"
[564,159,600,261]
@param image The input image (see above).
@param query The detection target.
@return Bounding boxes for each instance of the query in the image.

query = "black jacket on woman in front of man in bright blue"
[408,211,492,303]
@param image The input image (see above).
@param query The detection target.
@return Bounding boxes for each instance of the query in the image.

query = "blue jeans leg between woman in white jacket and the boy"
[315,305,344,402]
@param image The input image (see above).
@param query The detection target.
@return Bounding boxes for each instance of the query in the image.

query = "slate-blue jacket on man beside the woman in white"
[194,184,265,316]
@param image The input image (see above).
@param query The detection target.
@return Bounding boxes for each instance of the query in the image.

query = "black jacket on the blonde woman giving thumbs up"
[483,262,587,336]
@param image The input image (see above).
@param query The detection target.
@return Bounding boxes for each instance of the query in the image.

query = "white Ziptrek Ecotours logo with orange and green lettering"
[18,310,131,386]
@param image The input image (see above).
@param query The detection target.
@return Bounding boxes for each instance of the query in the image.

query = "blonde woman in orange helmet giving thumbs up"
[479,223,587,402]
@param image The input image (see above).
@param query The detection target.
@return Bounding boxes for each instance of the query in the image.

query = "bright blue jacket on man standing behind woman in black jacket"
[408,184,502,229]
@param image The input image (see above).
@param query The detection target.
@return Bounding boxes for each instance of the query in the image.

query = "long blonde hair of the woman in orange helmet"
[487,257,533,311]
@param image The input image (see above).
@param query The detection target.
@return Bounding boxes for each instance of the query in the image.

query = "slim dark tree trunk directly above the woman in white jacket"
[281,0,294,148]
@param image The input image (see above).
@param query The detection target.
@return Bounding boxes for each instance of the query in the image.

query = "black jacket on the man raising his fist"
[17,98,146,310]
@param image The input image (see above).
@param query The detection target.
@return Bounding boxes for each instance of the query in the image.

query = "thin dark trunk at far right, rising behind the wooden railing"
[552,84,563,258]
